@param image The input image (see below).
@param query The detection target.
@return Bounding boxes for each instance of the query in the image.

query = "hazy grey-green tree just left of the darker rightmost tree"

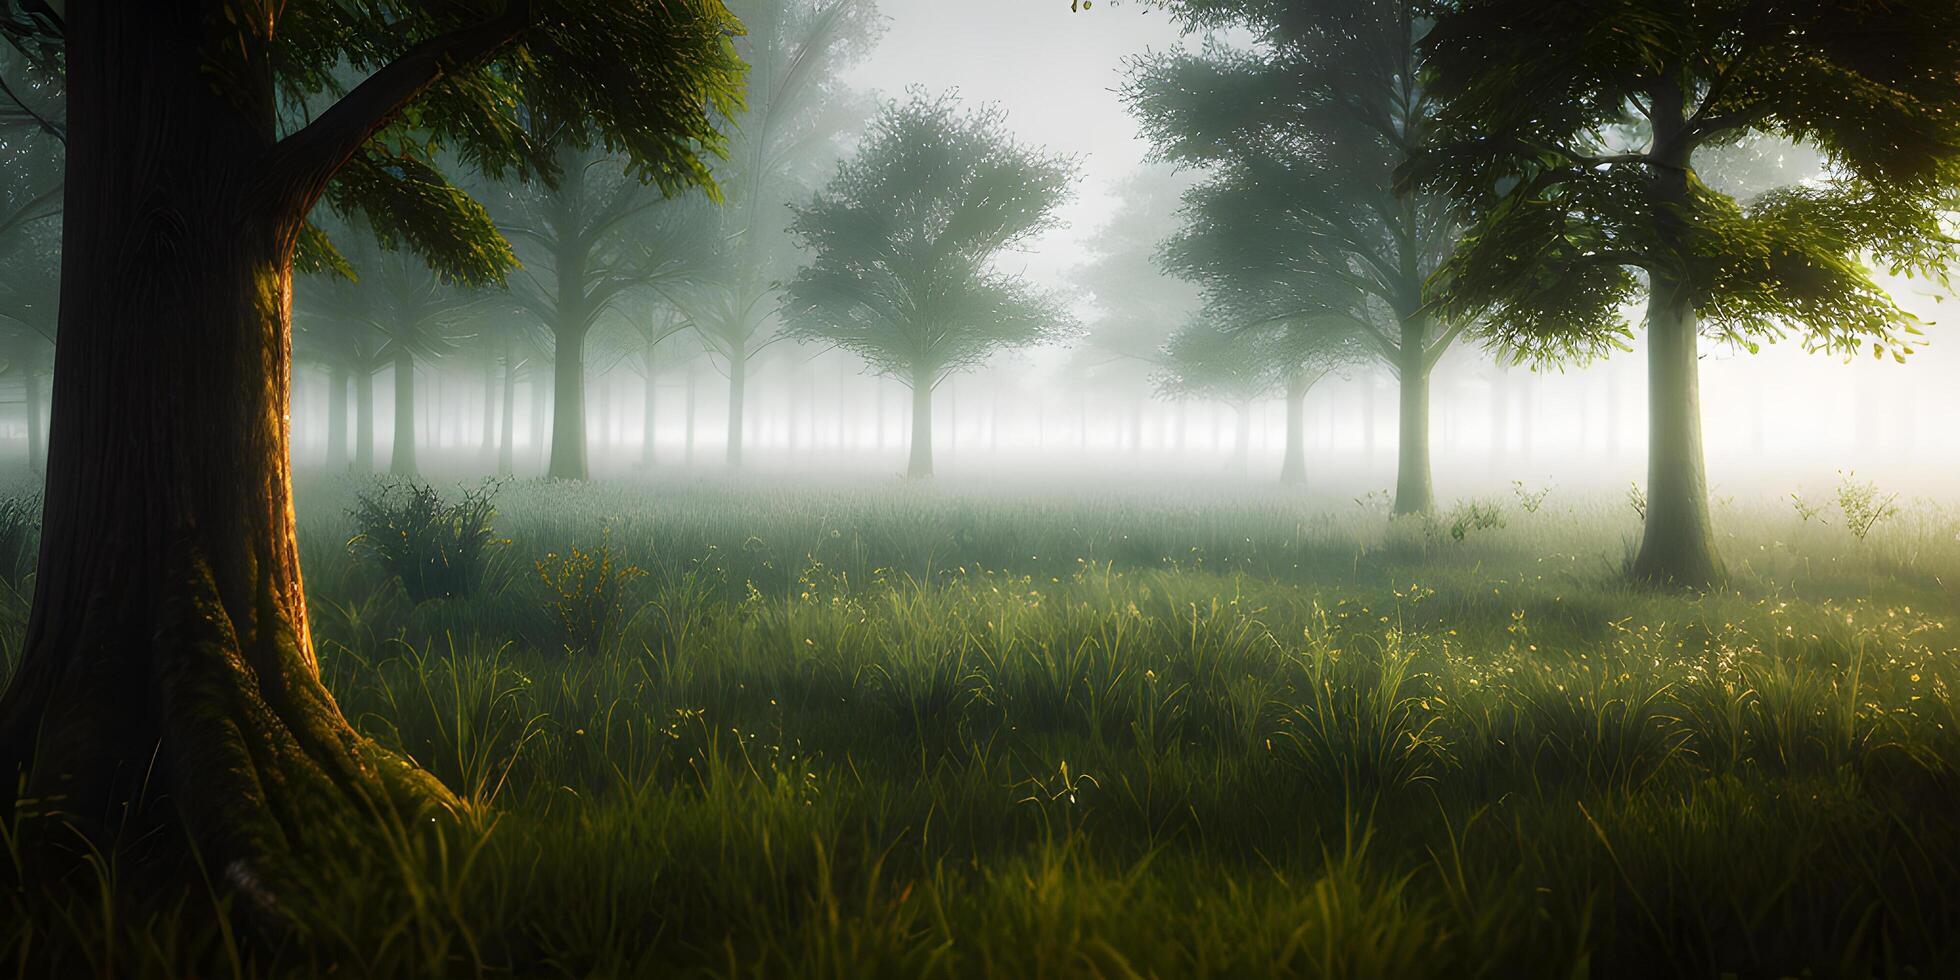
[1127,0,1470,514]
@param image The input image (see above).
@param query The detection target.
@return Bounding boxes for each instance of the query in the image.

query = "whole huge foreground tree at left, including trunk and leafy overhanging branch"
[0,0,741,909]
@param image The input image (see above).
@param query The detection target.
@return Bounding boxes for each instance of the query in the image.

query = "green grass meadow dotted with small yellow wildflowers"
[0,472,1960,978]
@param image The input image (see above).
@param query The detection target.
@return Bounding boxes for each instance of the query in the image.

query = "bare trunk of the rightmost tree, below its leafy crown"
[1633,276,1721,586]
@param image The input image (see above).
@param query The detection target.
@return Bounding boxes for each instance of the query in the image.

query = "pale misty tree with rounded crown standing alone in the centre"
[784,92,1074,478]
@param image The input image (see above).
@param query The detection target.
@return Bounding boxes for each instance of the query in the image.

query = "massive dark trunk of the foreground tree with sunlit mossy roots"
[0,2,451,909]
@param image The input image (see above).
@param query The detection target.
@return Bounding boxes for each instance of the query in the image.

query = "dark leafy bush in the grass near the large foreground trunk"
[347,480,504,604]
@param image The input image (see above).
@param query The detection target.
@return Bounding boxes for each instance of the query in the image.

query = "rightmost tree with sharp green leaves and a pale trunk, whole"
[1411,0,1960,586]
